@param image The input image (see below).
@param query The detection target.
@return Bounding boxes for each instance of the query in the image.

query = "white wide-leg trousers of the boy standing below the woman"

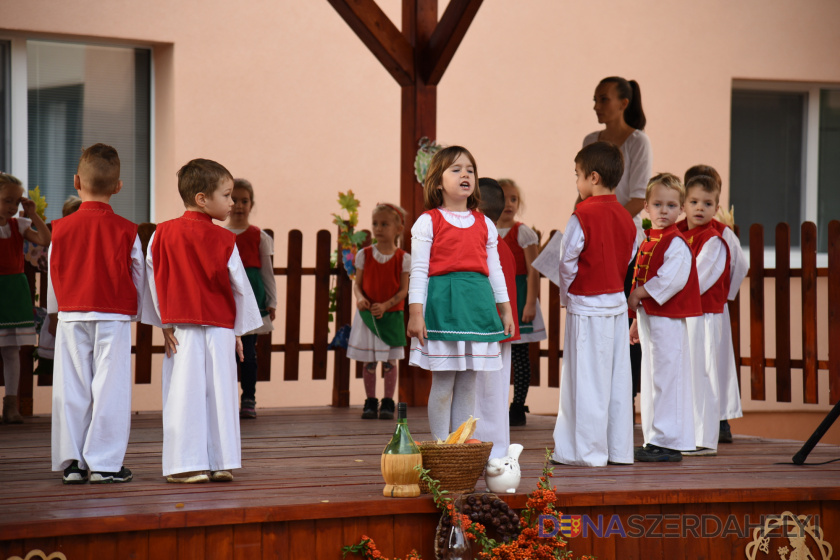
[552,312,633,467]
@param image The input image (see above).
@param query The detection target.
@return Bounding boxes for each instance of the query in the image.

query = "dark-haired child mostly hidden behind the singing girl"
[473,177,519,459]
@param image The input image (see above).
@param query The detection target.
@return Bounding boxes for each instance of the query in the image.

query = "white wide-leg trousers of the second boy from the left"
[163,325,242,476]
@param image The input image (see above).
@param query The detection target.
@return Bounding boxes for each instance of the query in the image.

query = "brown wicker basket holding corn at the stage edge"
[420,441,493,494]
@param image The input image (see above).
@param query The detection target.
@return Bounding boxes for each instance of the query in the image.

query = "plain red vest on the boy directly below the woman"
[569,194,636,296]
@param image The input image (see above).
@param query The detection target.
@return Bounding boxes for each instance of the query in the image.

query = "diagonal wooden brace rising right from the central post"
[421,0,482,86]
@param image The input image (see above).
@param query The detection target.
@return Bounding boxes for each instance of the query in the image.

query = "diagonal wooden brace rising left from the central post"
[328,0,414,86]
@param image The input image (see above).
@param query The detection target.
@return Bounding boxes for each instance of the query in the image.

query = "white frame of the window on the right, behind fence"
[730,80,840,268]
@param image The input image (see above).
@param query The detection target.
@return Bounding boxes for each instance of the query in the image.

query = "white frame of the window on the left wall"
[0,31,155,223]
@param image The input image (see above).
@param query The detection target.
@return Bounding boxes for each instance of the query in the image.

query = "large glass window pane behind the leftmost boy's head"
[26,41,151,222]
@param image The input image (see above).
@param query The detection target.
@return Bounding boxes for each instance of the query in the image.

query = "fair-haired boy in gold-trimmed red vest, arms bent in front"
[627,173,703,462]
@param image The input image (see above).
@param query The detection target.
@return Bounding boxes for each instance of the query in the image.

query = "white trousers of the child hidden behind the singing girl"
[473,342,511,459]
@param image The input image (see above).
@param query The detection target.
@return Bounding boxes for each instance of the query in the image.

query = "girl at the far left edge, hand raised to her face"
[0,172,50,424]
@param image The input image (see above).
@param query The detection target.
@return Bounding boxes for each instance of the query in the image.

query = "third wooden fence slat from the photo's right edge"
[775,223,791,402]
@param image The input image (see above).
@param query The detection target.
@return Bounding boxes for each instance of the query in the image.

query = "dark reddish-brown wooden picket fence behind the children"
[0,220,840,414]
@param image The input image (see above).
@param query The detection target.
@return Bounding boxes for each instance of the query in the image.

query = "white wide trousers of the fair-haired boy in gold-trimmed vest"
[637,308,695,451]
